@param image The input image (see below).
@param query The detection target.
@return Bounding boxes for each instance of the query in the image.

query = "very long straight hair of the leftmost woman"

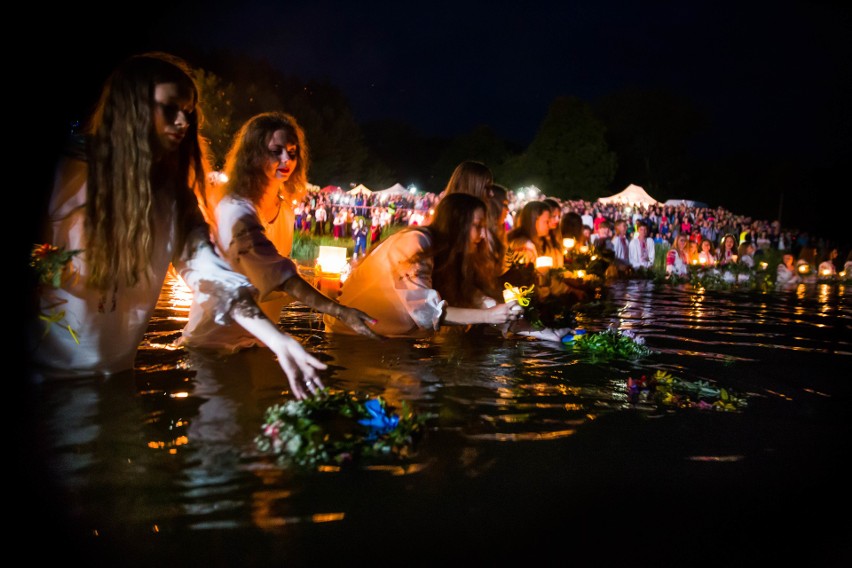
[85,52,209,290]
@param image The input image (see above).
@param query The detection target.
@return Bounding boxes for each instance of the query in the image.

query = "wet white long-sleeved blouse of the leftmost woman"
[31,159,254,379]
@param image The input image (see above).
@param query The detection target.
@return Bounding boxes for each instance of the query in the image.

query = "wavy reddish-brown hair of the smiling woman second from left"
[216,112,310,209]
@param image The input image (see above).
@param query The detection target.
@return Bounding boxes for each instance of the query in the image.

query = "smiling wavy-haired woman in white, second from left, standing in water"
[181,112,378,352]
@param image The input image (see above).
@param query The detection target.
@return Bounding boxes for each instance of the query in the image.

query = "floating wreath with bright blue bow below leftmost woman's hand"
[255,389,430,468]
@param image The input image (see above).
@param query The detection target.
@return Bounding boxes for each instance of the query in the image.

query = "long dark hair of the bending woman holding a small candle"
[411,193,496,308]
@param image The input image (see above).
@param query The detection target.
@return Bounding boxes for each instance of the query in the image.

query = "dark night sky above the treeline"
[32,0,852,242]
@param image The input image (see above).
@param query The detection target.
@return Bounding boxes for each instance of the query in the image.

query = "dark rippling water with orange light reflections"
[21,274,852,566]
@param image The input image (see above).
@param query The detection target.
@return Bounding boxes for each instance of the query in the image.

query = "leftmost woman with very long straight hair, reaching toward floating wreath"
[31,53,326,398]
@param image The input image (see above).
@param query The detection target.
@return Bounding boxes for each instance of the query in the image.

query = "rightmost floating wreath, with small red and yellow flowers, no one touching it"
[627,371,747,412]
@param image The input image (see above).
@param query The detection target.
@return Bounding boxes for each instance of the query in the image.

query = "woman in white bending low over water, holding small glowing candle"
[324,193,523,337]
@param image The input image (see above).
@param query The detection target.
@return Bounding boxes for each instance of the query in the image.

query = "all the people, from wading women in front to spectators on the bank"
[31,53,848,404]
